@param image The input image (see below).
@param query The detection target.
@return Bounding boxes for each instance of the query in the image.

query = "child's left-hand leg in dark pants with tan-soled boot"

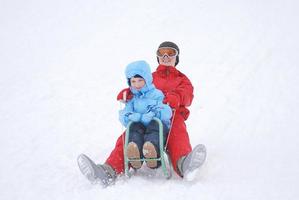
[127,122,145,169]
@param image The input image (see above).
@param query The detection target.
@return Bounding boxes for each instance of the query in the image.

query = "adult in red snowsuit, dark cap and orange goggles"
[78,41,206,185]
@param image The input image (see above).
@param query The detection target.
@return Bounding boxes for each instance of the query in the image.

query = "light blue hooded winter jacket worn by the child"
[119,61,172,128]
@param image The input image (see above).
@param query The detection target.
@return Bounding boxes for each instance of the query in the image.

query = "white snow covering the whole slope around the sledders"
[0,0,299,200]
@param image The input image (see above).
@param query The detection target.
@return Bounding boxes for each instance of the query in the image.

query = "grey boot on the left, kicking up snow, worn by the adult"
[77,154,116,187]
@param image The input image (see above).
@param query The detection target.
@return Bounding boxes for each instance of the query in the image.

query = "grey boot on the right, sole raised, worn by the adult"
[178,144,207,181]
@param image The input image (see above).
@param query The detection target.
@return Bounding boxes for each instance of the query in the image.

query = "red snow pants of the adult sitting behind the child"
[106,109,192,175]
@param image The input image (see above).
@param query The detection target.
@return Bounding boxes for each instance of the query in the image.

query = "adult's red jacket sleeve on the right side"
[171,74,194,107]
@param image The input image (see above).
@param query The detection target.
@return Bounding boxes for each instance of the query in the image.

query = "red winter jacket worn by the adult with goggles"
[117,65,193,120]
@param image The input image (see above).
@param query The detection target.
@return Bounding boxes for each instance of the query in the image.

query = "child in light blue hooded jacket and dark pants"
[119,61,172,169]
